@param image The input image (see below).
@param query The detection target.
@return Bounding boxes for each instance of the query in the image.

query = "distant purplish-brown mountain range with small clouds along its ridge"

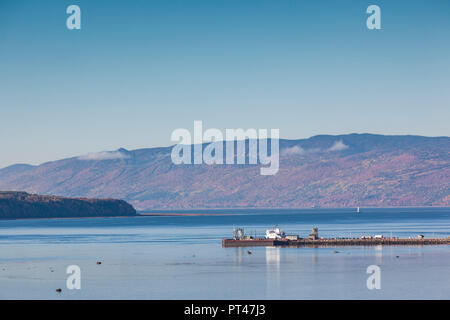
[0,134,450,210]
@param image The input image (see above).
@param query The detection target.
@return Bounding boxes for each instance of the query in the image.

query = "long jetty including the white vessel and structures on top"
[222,228,450,248]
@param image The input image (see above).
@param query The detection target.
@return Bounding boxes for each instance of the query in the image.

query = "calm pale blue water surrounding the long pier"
[0,208,450,299]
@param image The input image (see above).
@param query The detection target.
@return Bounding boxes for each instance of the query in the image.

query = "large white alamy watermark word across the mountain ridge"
[171,121,280,175]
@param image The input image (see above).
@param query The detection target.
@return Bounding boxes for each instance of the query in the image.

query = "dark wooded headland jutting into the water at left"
[0,192,136,219]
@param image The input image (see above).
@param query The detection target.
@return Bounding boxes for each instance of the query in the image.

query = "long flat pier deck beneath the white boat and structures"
[222,237,450,248]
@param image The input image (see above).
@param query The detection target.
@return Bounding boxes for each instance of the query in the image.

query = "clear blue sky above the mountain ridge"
[0,0,450,167]
